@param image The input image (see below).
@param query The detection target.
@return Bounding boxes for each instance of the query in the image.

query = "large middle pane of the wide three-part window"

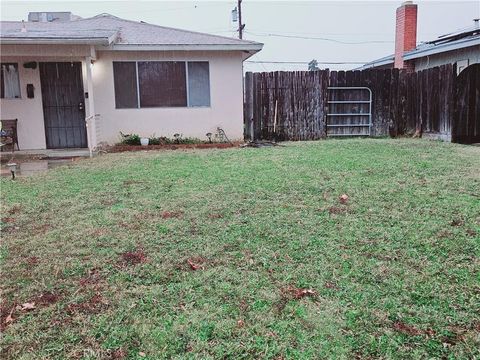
[138,61,187,107]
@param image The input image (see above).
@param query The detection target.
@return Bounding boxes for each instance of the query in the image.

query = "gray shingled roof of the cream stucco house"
[0,14,262,50]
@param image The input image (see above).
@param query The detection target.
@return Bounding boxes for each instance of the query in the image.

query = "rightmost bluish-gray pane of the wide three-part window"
[188,61,210,106]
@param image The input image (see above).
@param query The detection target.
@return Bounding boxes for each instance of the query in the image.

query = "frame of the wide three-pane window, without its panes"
[112,60,212,110]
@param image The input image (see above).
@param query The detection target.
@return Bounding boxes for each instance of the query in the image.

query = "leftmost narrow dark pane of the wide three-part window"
[113,62,138,109]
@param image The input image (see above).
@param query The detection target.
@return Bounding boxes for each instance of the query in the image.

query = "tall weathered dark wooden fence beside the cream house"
[245,65,474,140]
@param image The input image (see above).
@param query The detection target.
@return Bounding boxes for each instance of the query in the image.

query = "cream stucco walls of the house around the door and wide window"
[0,45,243,149]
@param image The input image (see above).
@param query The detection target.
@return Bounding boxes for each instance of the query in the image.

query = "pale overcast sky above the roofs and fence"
[1,0,480,71]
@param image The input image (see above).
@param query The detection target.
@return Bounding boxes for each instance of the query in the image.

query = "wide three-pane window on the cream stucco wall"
[113,61,210,109]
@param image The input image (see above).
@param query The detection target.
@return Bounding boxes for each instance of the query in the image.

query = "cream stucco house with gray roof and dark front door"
[0,13,263,149]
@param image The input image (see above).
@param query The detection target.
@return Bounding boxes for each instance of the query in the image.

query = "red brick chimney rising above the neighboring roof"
[395,1,417,71]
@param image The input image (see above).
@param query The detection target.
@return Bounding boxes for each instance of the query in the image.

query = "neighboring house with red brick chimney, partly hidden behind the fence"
[360,1,480,73]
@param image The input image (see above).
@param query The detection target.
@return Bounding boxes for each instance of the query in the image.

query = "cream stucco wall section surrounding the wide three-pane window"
[92,51,243,143]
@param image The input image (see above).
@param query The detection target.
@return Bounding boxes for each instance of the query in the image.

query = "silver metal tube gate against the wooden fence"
[327,86,372,136]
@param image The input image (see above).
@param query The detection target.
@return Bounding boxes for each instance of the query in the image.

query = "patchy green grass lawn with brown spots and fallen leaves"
[0,139,480,359]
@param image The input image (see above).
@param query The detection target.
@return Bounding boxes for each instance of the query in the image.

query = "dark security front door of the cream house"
[40,62,87,149]
